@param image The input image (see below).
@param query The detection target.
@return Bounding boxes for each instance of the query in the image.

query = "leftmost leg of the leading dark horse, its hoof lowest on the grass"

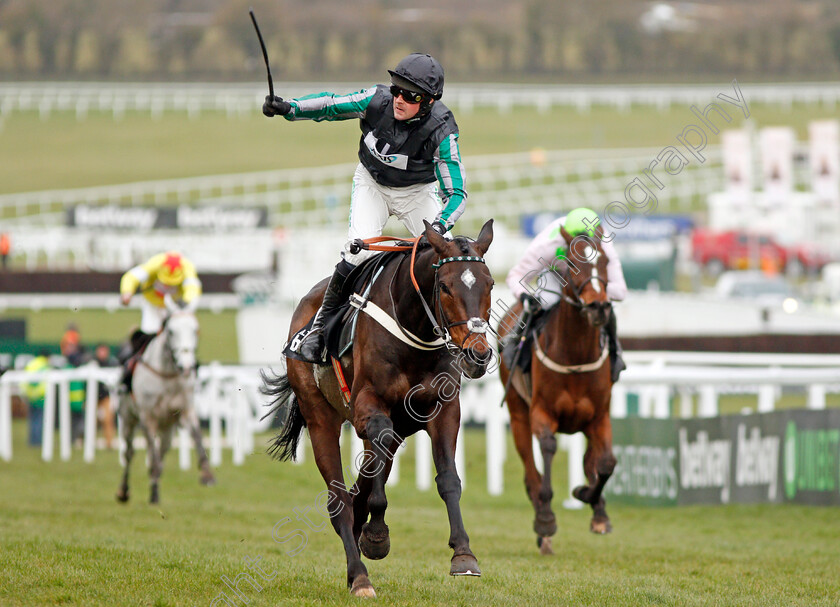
[308,418,376,597]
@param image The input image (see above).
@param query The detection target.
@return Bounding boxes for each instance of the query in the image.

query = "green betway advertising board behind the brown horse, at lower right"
[605,410,840,506]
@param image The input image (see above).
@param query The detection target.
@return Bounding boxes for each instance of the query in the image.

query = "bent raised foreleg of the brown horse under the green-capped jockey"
[572,416,616,533]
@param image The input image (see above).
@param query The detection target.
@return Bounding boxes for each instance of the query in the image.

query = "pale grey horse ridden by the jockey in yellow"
[117,296,215,504]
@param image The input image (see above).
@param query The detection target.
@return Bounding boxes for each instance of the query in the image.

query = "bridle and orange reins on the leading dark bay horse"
[350,236,487,353]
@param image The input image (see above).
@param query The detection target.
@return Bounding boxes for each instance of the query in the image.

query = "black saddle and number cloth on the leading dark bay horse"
[283,251,406,365]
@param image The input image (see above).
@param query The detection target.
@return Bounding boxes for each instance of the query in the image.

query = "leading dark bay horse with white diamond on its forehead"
[263,220,493,597]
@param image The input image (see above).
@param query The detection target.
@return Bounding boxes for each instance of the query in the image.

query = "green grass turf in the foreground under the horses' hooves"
[0,422,840,607]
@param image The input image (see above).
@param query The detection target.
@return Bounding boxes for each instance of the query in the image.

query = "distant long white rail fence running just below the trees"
[0,82,840,120]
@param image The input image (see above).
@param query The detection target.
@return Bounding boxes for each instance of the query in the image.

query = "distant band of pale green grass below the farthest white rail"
[0,101,836,193]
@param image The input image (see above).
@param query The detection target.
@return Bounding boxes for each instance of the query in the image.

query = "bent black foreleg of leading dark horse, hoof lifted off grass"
[353,413,402,559]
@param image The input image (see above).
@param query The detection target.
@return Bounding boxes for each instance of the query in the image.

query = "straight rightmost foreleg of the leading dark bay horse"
[426,406,481,575]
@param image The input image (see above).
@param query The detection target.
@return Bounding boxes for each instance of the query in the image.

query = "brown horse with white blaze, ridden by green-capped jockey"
[499,226,616,554]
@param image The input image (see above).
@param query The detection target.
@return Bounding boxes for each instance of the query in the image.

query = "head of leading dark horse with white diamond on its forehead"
[424,219,493,379]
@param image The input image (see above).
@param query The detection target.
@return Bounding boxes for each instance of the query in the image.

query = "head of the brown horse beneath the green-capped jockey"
[560,226,612,327]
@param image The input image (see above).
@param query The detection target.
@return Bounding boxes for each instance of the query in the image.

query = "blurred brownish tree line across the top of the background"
[0,0,840,81]
